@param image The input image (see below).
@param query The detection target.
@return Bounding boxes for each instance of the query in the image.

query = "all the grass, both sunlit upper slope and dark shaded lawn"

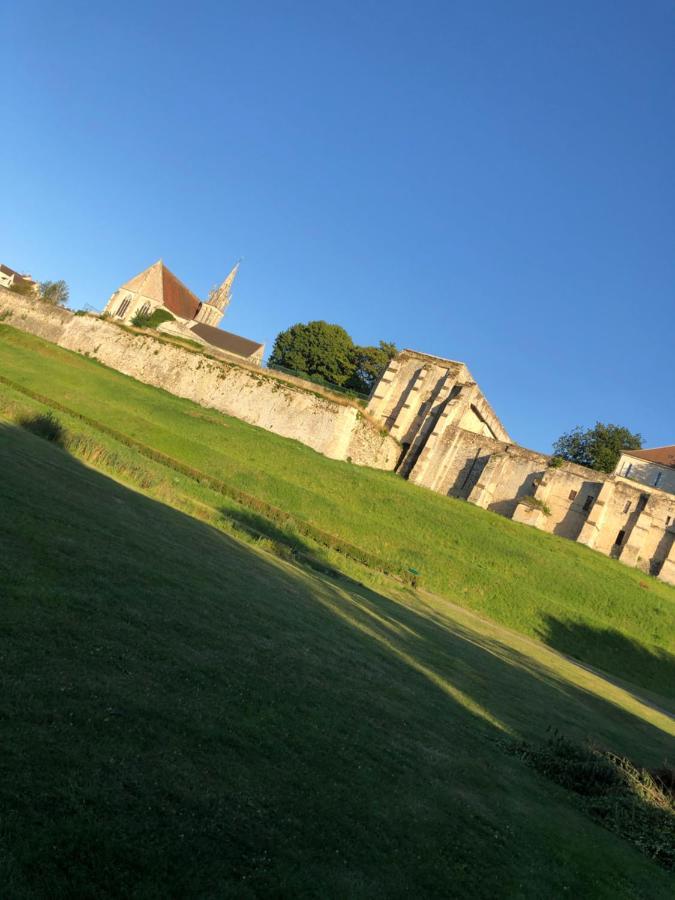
[0,326,675,898]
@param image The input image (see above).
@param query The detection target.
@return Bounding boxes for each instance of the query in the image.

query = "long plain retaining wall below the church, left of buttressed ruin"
[0,288,400,469]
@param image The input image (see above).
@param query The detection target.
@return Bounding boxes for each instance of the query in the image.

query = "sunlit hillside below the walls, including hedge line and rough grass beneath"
[0,325,675,703]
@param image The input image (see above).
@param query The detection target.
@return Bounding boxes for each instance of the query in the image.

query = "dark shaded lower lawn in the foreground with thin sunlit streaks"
[0,425,673,898]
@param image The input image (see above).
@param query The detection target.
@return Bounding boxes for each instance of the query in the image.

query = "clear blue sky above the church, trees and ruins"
[0,0,675,451]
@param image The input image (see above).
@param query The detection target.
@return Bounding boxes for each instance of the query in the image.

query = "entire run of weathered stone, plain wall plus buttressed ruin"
[0,288,675,584]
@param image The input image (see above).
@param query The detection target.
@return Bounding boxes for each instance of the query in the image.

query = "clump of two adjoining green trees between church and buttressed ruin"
[269,321,397,393]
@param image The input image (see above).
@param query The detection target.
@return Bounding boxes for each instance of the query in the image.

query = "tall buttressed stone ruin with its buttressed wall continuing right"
[368,350,675,584]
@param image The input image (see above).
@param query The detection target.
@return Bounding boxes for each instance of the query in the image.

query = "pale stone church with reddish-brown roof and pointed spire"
[104,260,265,365]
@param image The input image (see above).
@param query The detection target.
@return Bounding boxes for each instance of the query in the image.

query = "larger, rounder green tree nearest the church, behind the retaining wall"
[269,321,356,385]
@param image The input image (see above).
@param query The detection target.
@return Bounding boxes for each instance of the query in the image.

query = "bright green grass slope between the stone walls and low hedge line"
[0,325,675,697]
